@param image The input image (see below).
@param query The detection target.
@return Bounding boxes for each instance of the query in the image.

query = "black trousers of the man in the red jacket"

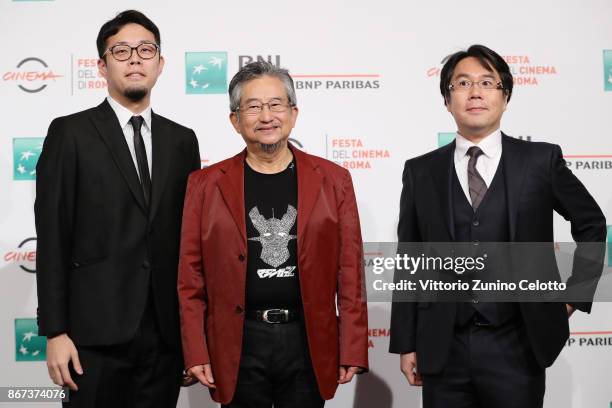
[223,319,325,408]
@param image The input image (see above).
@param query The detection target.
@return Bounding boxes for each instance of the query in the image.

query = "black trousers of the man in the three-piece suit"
[423,319,545,408]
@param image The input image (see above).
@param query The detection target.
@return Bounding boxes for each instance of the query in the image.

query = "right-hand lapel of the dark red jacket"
[289,144,324,249]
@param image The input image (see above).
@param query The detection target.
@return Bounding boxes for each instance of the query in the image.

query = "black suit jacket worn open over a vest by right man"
[389,135,606,374]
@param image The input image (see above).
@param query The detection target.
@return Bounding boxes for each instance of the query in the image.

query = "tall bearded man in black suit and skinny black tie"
[34,10,200,408]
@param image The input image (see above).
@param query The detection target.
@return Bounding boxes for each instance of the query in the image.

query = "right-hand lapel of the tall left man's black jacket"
[149,112,174,220]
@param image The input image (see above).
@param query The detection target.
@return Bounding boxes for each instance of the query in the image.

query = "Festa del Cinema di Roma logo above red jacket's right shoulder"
[325,135,391,170]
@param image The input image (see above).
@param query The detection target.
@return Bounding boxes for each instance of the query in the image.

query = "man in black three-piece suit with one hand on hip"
[389,45,606,408]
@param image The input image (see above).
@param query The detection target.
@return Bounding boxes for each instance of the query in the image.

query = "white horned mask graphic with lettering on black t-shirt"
[249,204,297,268]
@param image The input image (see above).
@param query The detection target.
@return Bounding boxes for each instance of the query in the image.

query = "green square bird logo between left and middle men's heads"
[185,52,227,94]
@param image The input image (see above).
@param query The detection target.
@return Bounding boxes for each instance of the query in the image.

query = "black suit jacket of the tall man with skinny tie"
[34,100,200,347]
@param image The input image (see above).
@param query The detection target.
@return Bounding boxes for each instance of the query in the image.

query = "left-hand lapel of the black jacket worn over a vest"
[431,141,455,240]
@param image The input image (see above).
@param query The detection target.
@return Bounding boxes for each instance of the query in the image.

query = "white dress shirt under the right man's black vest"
[455,129,502,205]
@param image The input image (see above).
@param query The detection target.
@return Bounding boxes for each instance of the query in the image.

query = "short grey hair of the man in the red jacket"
[228,61,297,112]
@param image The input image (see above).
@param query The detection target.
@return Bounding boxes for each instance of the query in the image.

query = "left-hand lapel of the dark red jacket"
[217,149,246,246]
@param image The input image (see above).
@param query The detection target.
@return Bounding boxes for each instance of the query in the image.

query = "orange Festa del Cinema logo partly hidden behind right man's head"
[427,55,557,86]
